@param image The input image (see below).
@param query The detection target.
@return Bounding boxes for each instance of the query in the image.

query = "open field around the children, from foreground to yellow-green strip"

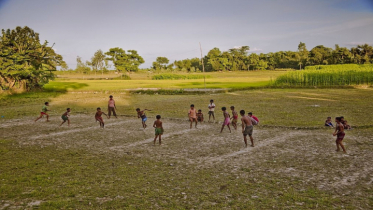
[0,71,373,209]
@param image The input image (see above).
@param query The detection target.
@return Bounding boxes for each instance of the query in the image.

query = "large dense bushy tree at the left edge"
[0,26,63,90]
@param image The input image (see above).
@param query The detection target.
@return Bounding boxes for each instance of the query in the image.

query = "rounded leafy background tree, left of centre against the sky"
[105,47,145,72]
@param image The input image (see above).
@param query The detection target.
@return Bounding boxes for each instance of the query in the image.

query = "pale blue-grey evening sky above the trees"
[0,0,373,69]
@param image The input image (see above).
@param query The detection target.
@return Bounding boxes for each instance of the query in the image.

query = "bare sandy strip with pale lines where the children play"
[0,115,373,202]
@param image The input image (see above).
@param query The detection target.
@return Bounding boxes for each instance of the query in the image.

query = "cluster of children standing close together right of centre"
[188,99,259,147]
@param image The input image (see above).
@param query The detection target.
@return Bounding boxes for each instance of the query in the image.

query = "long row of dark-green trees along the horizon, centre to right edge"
[152,42,373,72]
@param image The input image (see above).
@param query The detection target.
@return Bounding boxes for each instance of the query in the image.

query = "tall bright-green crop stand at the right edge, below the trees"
[274,64,373,87]
